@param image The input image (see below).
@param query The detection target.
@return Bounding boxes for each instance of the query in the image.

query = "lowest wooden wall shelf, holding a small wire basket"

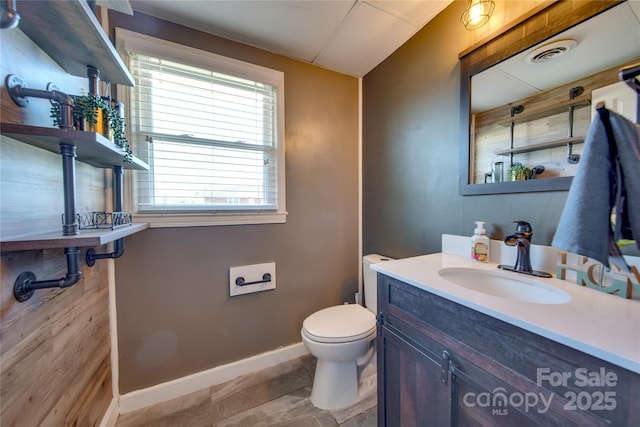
[0,222,149,252]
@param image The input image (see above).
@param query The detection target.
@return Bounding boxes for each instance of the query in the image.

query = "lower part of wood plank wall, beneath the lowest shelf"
[0,250,112,426]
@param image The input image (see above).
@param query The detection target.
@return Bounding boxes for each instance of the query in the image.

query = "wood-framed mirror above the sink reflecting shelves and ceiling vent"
[460,1,640,195]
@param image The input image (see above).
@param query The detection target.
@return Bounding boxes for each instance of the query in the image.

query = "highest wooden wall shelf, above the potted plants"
[17,0,135,86]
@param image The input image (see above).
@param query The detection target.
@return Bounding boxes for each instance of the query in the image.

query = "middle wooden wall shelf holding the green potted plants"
[0,123,149,170]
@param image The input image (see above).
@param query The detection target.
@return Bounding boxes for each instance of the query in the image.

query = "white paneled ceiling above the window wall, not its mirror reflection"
[131,0,452,77]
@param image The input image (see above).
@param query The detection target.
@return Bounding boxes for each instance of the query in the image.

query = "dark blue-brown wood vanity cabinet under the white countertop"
[377,274,640,427]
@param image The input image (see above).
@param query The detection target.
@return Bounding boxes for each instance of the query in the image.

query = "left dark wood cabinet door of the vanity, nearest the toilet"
[378,327,451,427]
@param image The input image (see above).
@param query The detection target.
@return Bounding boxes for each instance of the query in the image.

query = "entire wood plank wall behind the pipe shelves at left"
[0,18,113,427]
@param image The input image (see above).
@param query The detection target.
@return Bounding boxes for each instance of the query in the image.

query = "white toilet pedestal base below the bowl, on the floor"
[311,360,361,409]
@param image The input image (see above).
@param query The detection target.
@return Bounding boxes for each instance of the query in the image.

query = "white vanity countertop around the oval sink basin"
[372,253,640,373]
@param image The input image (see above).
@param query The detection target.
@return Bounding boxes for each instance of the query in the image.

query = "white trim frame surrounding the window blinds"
[115,28,287,227]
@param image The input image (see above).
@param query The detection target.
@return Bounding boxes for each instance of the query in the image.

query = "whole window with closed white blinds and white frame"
[116,29,286,226]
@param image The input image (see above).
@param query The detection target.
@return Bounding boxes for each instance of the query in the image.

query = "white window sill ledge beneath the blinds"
[134,212,287,228]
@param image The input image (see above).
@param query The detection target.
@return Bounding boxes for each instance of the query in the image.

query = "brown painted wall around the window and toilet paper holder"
[110,13,358,393]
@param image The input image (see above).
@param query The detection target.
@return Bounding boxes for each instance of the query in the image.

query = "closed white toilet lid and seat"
[302,304,376,342]
